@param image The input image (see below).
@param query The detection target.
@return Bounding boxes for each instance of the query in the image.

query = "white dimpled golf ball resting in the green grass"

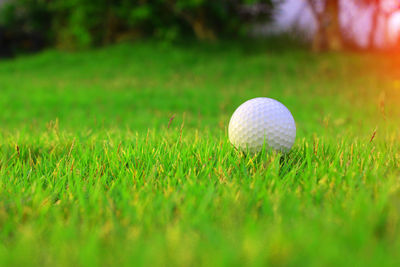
[228,97,296,153]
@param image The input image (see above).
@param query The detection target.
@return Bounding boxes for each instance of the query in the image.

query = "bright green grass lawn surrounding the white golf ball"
[0,42,400,266]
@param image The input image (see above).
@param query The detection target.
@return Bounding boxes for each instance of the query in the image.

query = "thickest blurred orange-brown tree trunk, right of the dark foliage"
[323,0,343,51]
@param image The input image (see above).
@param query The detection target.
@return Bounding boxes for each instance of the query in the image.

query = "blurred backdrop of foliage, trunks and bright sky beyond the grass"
[0,0,400,57]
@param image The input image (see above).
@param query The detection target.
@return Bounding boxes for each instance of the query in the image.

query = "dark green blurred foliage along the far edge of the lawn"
[0,0,274,53]
